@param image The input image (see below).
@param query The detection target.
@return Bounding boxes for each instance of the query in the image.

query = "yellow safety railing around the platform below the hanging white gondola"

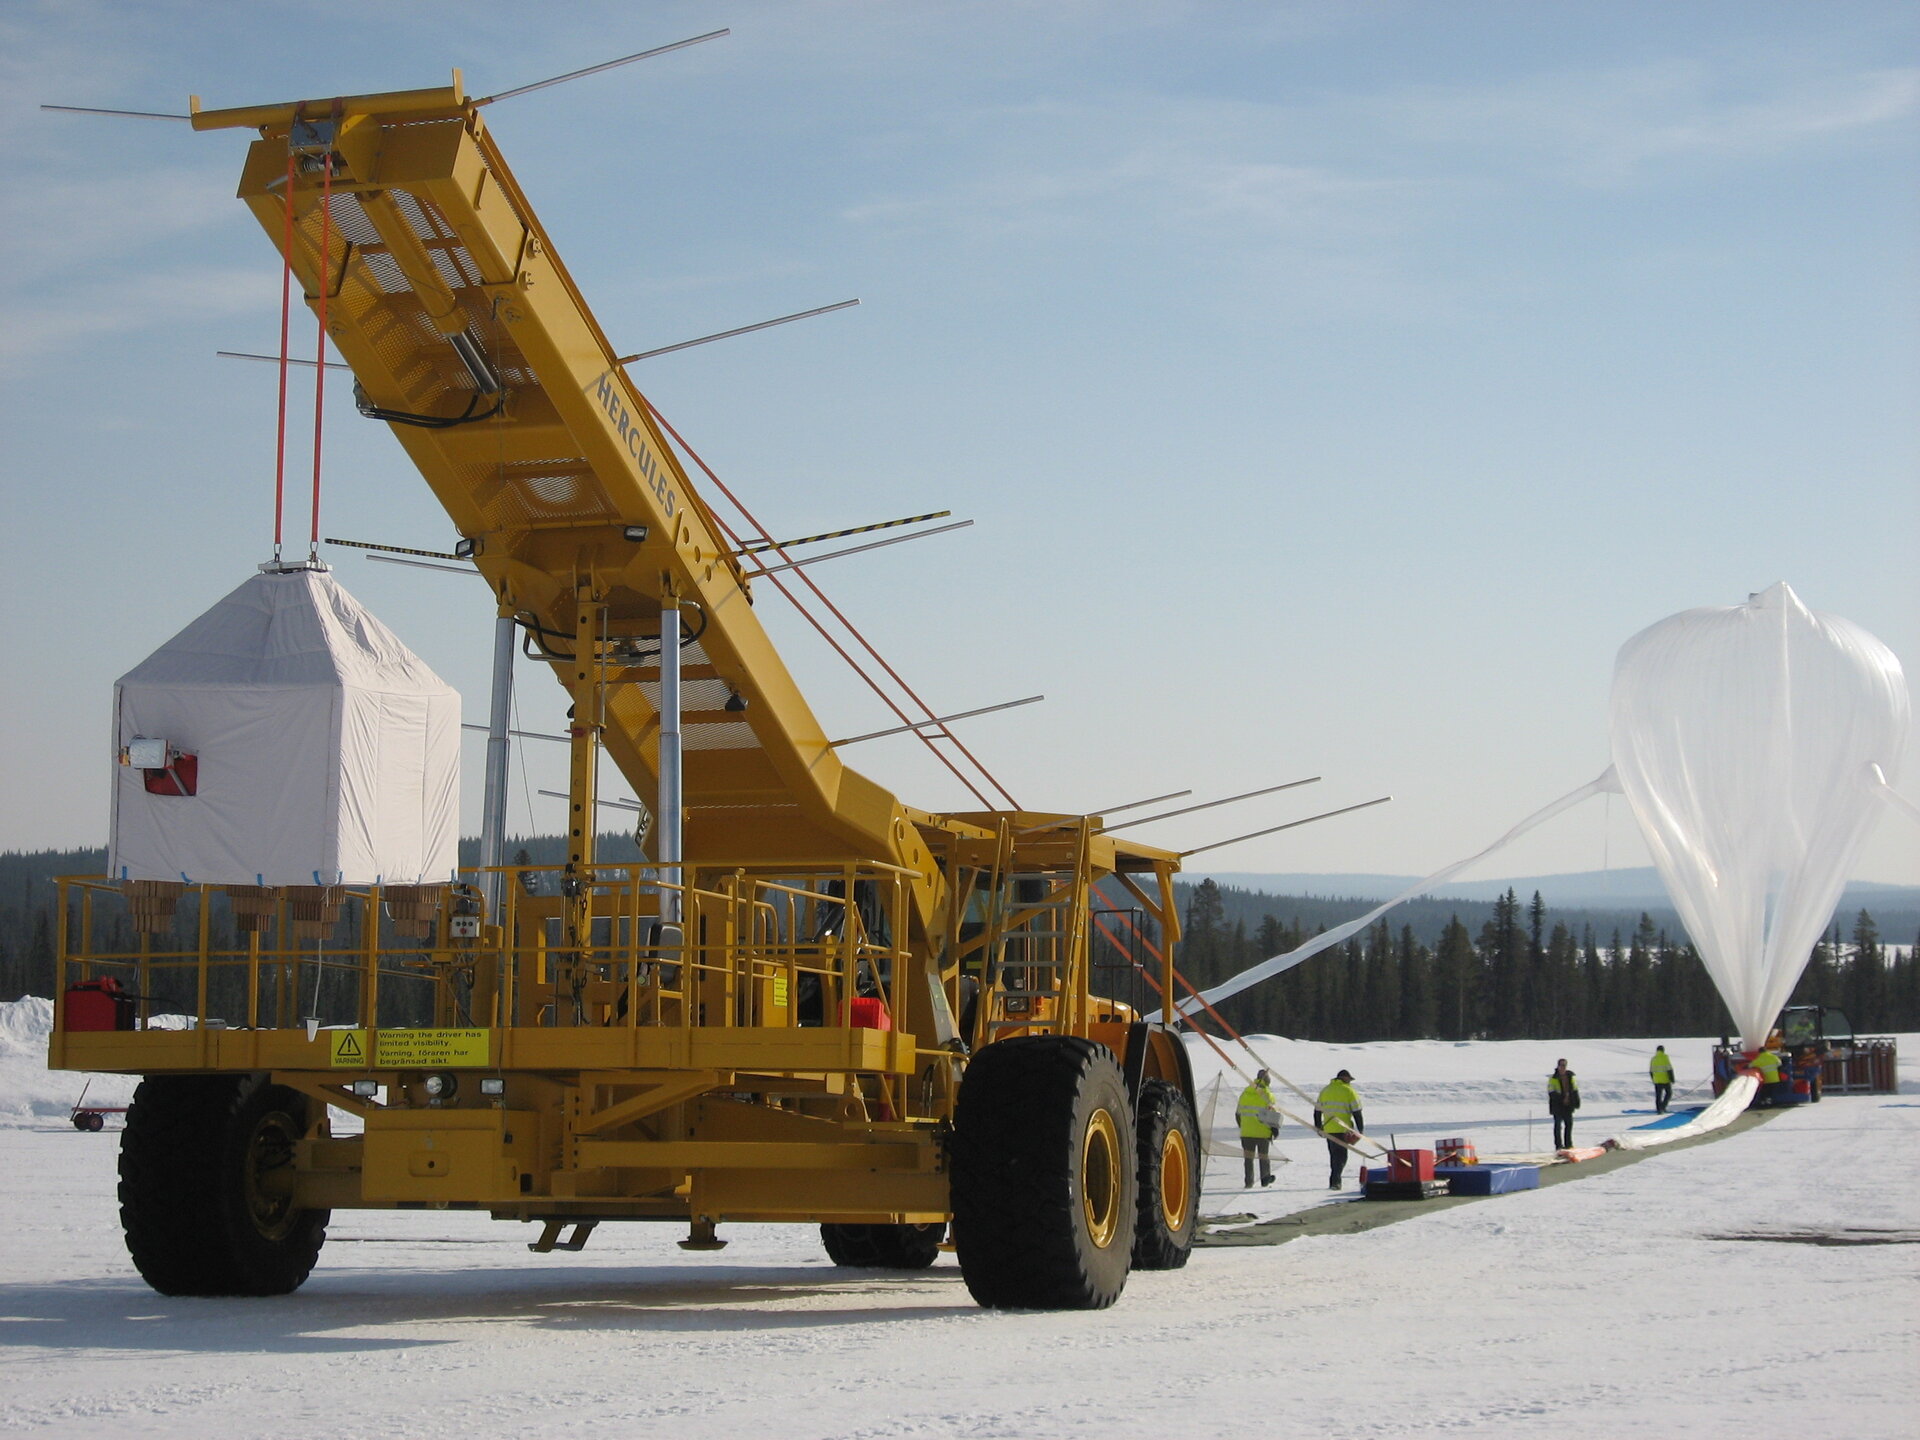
[58,864,908,1029]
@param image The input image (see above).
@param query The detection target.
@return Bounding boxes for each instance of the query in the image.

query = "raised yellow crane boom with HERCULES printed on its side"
[192,77,913,890]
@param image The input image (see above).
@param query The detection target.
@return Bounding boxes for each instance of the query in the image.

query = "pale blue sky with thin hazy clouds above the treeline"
[0,0,1920,883]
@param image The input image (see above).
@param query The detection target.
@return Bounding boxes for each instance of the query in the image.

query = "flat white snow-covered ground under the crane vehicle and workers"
[0,1006,1920,1440]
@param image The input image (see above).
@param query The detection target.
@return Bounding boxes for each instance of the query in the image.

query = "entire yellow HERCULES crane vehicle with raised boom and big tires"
[48,73,1200,1308]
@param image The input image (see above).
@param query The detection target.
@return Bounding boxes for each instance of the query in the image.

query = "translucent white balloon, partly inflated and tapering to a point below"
[1611,584,1908,1050]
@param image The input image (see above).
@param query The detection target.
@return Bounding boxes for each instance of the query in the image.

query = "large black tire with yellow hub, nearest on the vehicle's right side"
[950,1035,1137,1309]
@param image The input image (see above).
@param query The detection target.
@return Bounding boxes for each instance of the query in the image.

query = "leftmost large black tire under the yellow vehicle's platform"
[119,1075,330,1296]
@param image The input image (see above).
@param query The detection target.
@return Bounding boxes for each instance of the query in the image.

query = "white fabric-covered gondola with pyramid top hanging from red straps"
[108,568,461,885]
